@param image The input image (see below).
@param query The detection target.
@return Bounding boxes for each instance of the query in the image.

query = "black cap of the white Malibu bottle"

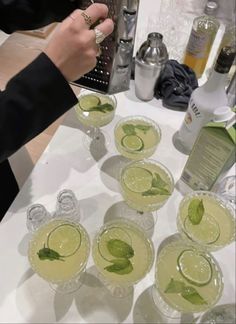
[215,46,236,73]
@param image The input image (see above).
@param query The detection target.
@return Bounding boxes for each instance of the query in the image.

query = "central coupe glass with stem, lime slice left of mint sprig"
[120,159,174,231]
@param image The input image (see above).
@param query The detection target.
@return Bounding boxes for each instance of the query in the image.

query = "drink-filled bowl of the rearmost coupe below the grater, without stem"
[75,90,116,127]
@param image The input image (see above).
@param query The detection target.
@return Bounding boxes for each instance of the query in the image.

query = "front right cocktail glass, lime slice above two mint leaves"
[153,240,223,318]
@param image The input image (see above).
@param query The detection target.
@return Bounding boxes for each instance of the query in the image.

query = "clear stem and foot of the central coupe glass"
[121,204,157,232]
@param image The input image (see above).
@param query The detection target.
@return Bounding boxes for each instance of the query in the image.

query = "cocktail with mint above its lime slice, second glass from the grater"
[114,116,161,160]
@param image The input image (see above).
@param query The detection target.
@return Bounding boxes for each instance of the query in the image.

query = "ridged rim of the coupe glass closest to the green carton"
[176,190,236,251]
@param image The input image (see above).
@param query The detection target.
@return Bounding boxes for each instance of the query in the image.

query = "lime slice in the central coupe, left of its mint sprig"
[123,167,153,193]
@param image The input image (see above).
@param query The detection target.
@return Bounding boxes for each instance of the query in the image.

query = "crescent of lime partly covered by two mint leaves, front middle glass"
[98,226,132,262]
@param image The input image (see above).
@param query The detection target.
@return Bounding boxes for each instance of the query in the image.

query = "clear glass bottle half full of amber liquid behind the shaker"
[183,1,220,78]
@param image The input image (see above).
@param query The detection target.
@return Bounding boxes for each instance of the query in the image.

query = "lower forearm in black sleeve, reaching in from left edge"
[0,53,77,162]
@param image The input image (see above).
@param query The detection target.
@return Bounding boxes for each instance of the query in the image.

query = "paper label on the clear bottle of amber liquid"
[187,29,208,58]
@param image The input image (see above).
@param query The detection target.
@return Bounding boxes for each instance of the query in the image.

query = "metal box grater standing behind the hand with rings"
[73,0,139,94]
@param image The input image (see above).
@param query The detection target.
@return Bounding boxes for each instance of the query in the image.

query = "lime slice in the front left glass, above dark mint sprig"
[47,224,81,257]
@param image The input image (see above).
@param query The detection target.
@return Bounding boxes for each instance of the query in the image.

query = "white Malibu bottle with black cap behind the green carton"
[175,46,236,154]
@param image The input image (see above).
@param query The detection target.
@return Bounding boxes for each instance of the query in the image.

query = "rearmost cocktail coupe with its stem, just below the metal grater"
[75,89,117,150]
